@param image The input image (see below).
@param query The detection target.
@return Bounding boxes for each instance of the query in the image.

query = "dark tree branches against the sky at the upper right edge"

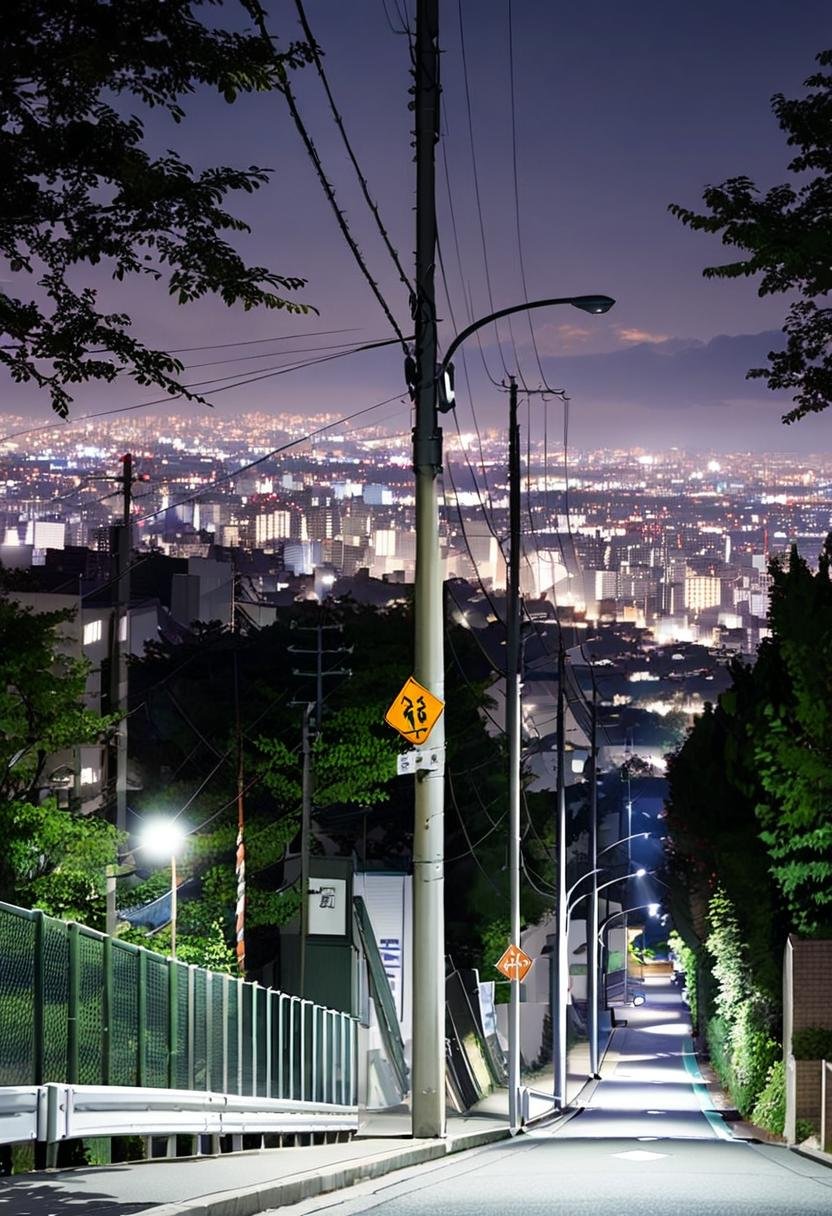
[670,50,832,423]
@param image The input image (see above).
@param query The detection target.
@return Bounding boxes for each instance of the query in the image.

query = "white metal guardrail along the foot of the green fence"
[0,1085,358,1144]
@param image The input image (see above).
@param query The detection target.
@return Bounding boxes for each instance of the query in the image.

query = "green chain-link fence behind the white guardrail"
[0,903,358,1105]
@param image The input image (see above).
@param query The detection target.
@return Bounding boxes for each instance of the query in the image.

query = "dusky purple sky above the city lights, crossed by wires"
[6,0,832,451]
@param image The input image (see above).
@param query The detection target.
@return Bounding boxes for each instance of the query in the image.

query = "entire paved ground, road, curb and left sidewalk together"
[0,979,832,1216]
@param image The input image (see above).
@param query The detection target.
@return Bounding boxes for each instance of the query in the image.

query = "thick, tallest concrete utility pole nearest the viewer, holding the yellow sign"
[412,0,445,1137]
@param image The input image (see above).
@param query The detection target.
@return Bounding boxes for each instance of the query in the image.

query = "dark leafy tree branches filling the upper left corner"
[0,0,309,417]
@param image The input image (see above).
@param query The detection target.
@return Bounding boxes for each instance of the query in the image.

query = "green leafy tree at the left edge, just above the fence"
[0,596,117,925]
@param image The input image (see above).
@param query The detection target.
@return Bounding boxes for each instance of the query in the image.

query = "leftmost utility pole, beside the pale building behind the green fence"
[106,452,134,934]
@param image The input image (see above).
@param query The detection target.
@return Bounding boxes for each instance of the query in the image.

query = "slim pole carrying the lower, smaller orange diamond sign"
[506,376,522,1135]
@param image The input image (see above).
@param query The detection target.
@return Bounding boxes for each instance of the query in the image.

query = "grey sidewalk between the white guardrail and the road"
[0,1090,508,1216]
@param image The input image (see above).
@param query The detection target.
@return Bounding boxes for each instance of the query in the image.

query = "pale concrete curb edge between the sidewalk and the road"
[134,1127,510,1216]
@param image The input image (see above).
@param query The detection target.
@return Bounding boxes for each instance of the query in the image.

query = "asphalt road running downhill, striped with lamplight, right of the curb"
[275,983,832,1216]
